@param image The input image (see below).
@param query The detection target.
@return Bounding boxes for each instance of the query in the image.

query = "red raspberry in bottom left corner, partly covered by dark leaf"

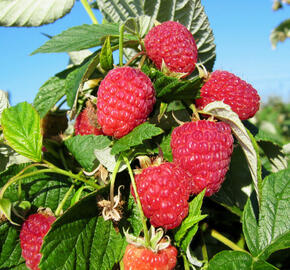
[20,213,55,270]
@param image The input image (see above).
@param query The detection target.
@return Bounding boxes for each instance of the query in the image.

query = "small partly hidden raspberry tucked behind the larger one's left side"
[74,107,103,135]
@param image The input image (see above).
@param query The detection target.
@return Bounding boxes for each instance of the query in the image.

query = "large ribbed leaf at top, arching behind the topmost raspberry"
[98,0,215,71]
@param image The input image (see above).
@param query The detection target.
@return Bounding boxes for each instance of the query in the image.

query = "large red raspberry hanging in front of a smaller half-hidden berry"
[97,67,156,138]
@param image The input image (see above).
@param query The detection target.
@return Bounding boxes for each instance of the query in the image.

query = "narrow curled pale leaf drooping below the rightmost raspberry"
[203,101,261,206]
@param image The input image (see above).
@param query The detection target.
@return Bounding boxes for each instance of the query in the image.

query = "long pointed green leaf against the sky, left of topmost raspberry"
[32,23,136,54]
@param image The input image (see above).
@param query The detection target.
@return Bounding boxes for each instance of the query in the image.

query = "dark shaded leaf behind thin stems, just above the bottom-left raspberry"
[0,164,74,211]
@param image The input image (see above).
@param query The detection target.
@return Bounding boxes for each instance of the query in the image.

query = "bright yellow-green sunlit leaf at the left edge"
[1,102,42,161]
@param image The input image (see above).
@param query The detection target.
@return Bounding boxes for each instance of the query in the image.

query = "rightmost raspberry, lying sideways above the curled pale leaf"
[196,70,260,120]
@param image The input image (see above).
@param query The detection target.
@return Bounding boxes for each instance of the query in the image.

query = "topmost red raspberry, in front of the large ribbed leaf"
[144,21,197,77]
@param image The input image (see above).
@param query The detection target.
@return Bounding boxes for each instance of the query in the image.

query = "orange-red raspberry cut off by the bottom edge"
[123,244,177,270]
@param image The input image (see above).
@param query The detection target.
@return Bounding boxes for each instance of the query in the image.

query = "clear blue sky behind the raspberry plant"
[0,0,290,105]
